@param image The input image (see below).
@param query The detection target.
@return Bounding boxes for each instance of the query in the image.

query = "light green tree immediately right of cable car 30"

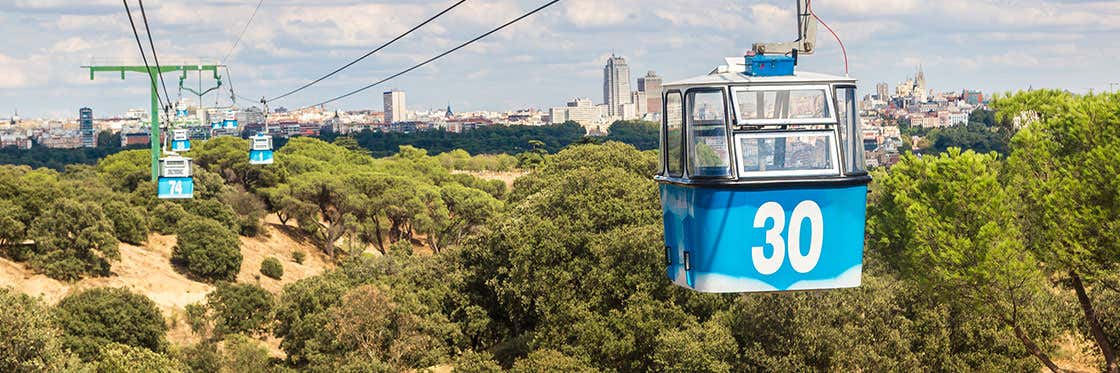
[868,148,1060,372]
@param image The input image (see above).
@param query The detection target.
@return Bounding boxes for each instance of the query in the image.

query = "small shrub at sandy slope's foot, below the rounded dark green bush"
[206,282,276,335]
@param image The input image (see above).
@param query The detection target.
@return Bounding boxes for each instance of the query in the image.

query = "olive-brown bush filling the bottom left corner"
[0,288,75,372]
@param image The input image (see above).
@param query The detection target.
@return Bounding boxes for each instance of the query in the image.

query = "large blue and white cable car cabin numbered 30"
[656,64,870,292]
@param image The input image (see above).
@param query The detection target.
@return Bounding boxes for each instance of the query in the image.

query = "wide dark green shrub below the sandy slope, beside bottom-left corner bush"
[54,288,167,360]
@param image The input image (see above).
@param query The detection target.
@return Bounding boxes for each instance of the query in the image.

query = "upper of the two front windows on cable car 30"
[734,85,834,124]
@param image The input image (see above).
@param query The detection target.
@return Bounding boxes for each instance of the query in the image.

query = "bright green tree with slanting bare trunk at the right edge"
[993,90,1120,373]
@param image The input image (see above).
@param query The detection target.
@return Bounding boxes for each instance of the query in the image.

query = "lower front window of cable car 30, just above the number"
[735,131,840,177]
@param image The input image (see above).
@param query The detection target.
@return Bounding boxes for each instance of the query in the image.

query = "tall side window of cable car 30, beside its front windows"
[688,90,731,177]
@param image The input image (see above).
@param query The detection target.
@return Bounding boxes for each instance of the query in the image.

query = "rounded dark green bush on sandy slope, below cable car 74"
[171,217,241,280]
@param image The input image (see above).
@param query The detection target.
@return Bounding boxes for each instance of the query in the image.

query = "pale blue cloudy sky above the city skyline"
[0,0,1120,119]
